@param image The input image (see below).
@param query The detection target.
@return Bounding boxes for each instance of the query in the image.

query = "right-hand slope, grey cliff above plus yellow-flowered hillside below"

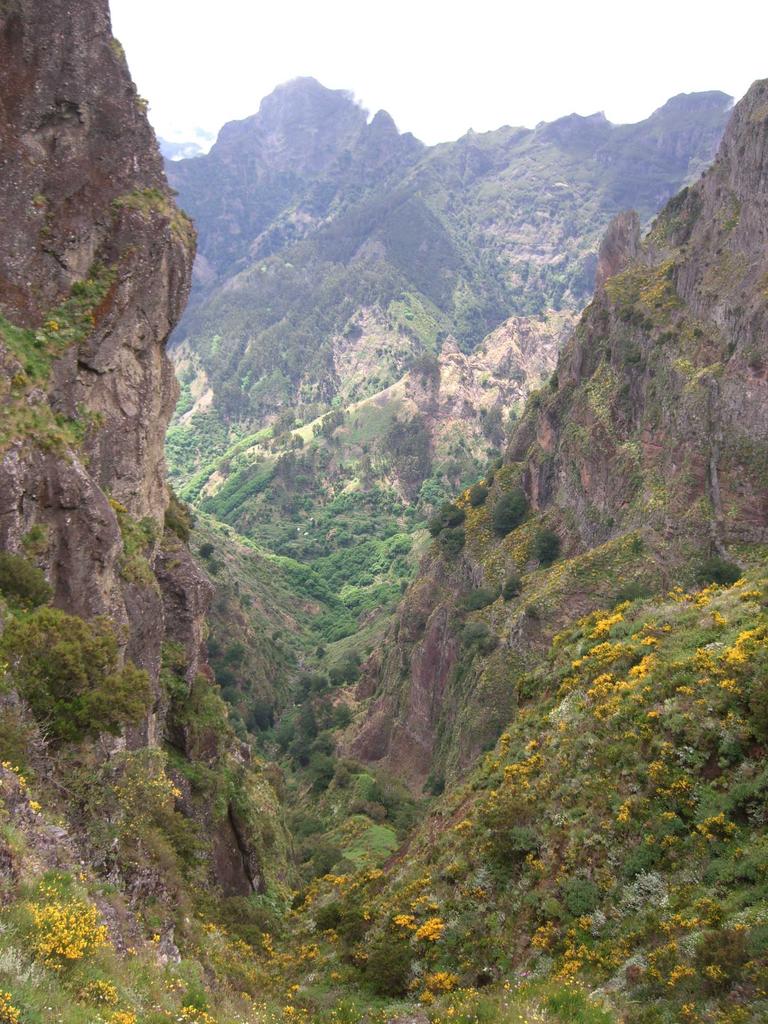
[253,81,768,1024]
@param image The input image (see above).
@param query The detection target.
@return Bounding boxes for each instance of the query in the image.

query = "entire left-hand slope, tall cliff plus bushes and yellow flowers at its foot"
[0,0,287,1024]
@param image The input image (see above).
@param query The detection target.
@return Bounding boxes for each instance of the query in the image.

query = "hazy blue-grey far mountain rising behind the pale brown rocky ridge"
[168,79,730,425]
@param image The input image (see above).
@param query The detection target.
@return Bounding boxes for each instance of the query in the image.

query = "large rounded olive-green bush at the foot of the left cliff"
[0,608,151,741]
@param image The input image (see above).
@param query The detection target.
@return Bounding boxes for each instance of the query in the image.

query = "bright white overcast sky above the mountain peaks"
[111,0,768,144]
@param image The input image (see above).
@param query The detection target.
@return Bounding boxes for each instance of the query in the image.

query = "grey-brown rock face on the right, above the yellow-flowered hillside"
[350,82,768,782]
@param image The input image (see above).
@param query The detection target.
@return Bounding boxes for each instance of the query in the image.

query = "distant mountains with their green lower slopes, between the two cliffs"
[162,79,730,733]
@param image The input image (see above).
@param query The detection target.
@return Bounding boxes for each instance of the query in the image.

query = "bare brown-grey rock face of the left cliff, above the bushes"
[0,0,205,739]
